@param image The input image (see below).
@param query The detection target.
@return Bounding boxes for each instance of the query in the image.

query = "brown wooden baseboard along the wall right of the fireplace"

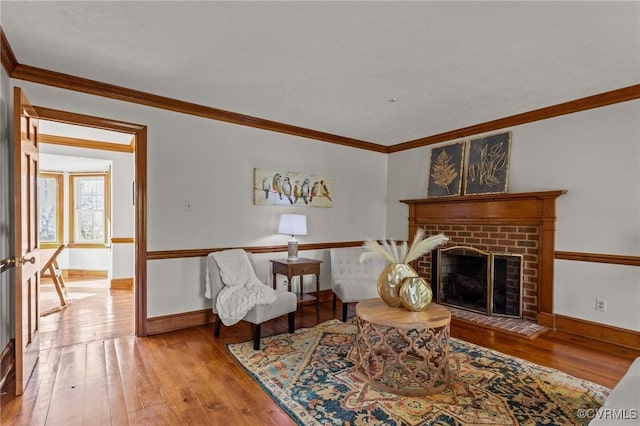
[555,314,640,350]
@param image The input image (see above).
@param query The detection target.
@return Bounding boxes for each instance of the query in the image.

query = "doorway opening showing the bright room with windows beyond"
[38,119,135,350]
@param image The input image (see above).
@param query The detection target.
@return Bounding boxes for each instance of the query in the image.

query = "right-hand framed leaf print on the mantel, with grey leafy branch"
[464,132,511,195]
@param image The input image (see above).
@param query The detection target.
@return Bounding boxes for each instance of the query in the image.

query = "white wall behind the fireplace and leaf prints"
[387,100,640,331]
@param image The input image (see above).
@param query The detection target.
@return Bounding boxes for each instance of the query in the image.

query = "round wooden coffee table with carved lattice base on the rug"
[356,299,451,396]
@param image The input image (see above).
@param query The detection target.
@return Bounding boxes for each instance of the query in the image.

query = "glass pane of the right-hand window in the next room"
[74,176,105,243]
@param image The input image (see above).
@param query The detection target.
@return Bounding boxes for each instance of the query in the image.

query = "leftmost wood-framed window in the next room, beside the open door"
[38,173,64,248]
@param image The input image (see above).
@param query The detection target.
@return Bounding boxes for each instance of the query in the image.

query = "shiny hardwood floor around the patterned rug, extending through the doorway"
[0,284,640,426]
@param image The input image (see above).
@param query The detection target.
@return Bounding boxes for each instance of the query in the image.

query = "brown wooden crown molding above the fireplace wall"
[388,84,640,153]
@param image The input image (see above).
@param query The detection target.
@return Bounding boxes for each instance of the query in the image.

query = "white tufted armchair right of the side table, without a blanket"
[330,247,386,322]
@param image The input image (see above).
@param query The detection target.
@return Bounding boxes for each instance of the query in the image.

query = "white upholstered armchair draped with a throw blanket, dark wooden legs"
[205,250,298,350]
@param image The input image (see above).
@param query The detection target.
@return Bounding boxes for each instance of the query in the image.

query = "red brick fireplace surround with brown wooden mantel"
[402,190,566,326]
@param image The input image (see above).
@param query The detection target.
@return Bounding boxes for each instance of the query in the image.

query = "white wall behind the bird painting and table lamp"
[12,80,387,317]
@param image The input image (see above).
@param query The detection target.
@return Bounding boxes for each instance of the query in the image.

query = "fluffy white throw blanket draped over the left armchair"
[213,249,277,325]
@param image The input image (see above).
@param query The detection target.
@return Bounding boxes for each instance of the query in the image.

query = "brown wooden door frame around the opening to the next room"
[33,105,147,337]
